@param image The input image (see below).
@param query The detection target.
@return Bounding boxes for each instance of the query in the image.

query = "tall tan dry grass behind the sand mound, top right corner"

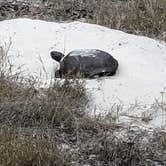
[91,0,166,40]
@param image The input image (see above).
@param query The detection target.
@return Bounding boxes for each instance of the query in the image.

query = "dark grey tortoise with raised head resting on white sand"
[50,49,118,78]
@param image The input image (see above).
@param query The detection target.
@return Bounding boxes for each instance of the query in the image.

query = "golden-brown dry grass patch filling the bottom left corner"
[0,128,67,166]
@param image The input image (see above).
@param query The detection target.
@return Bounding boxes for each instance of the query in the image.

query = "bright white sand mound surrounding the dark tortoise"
[0,19,166,127]
